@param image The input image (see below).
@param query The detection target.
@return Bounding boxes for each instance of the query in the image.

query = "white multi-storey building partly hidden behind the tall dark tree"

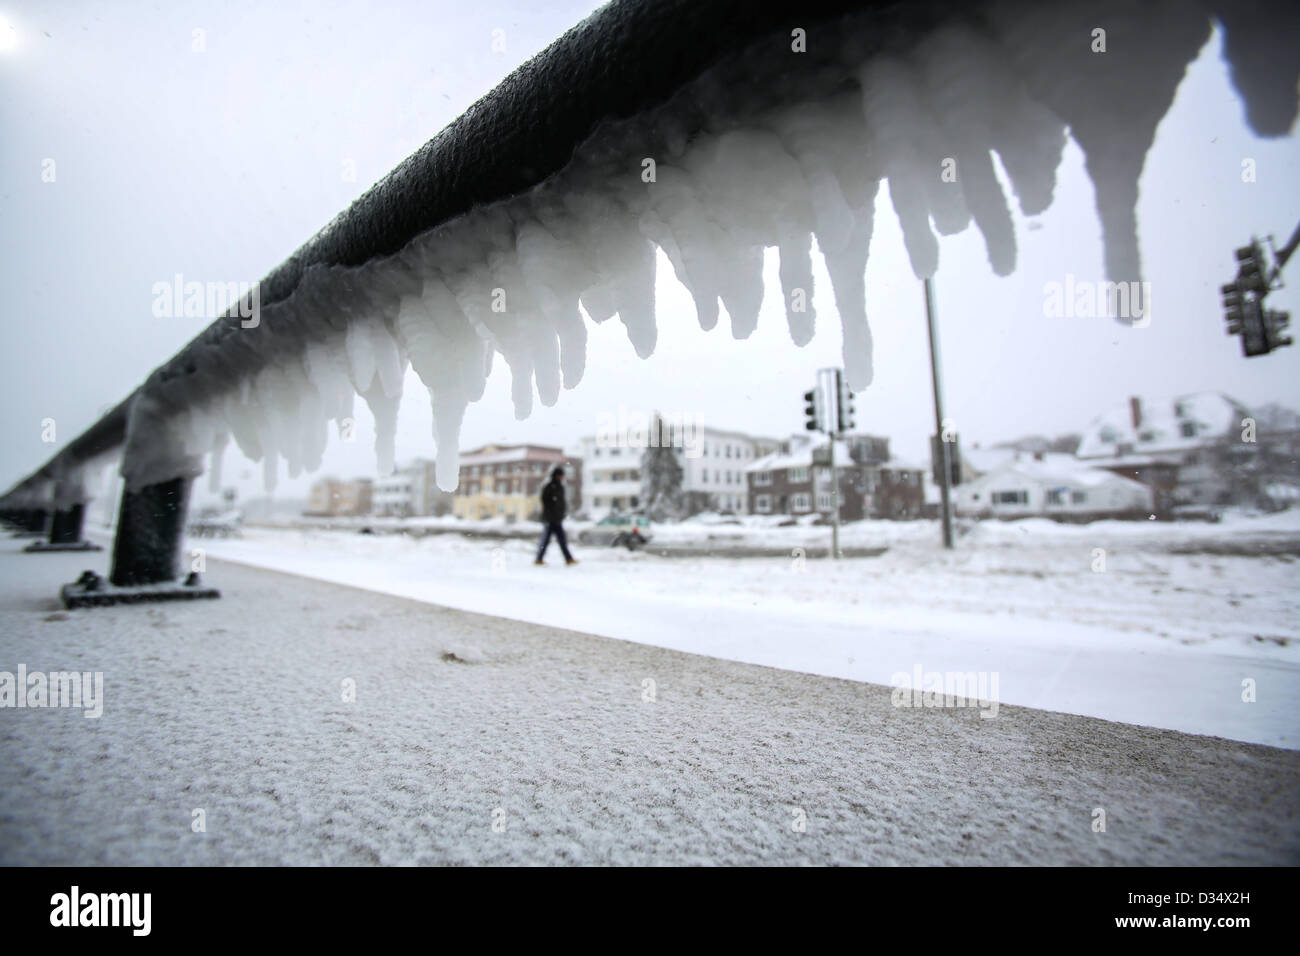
[582,425,781,519]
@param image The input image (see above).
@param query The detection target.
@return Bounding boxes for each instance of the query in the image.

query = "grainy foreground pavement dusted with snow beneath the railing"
[0,542,1300,865]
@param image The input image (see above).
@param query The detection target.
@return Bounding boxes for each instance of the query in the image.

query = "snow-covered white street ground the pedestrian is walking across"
[191,512,1300,748]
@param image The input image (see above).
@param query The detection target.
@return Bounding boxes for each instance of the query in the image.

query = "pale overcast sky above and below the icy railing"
[0,0,1300,509]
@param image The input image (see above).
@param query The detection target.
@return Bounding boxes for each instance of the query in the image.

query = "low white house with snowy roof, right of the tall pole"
[953,454,1152,522]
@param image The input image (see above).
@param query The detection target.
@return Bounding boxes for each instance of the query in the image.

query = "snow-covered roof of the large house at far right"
[1078,392,1249,458]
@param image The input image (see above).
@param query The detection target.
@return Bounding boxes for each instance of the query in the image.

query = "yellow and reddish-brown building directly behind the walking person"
[452,445,582,522]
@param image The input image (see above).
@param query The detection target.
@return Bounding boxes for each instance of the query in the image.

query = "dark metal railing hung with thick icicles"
[0,0,1300,598]
